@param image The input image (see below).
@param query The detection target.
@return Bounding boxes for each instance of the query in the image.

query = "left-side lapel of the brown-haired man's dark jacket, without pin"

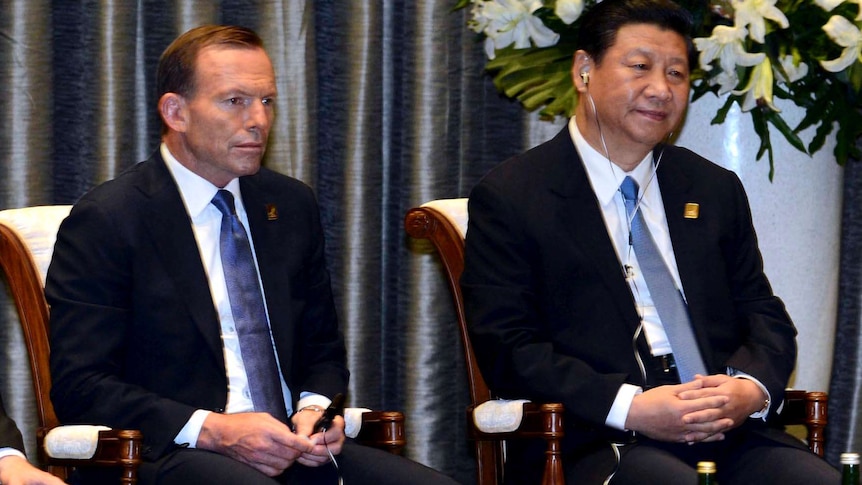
[133,155,224,365]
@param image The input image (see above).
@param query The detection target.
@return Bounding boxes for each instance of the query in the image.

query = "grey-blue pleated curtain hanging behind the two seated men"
[0,0,862,483]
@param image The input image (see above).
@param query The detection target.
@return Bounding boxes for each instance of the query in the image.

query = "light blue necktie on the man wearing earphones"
[620,177,706,382]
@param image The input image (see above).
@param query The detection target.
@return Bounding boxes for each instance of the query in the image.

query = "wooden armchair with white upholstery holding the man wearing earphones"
[404,198,827,485]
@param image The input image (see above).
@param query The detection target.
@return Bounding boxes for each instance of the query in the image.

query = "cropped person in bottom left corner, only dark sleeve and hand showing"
[0,399,63,485]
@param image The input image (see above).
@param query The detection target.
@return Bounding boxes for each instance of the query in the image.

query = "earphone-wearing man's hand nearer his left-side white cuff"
[626,380,732,443]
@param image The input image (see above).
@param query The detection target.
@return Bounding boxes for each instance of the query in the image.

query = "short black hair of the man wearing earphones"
[578,0,697,69]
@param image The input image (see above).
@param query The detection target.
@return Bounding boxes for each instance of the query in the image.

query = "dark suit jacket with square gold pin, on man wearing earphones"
[461,128,796,448]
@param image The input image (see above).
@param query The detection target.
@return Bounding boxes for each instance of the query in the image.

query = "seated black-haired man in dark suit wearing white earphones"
[461,0,838,485]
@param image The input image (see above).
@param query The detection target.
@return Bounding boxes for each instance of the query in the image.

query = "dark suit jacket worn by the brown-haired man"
[46,153,348,459]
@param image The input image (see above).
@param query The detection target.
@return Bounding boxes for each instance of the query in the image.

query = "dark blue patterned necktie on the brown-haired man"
[212,190,287,423]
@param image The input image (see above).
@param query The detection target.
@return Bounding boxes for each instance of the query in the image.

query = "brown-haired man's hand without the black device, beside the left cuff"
[196,413,313,477]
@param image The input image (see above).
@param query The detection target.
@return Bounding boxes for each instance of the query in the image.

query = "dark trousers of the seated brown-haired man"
[73,440,456,485]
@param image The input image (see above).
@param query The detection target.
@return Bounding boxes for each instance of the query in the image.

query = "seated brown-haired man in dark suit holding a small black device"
[46,26,460,484]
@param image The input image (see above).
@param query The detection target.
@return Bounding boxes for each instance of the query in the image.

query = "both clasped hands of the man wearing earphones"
[626,374,766,444]
